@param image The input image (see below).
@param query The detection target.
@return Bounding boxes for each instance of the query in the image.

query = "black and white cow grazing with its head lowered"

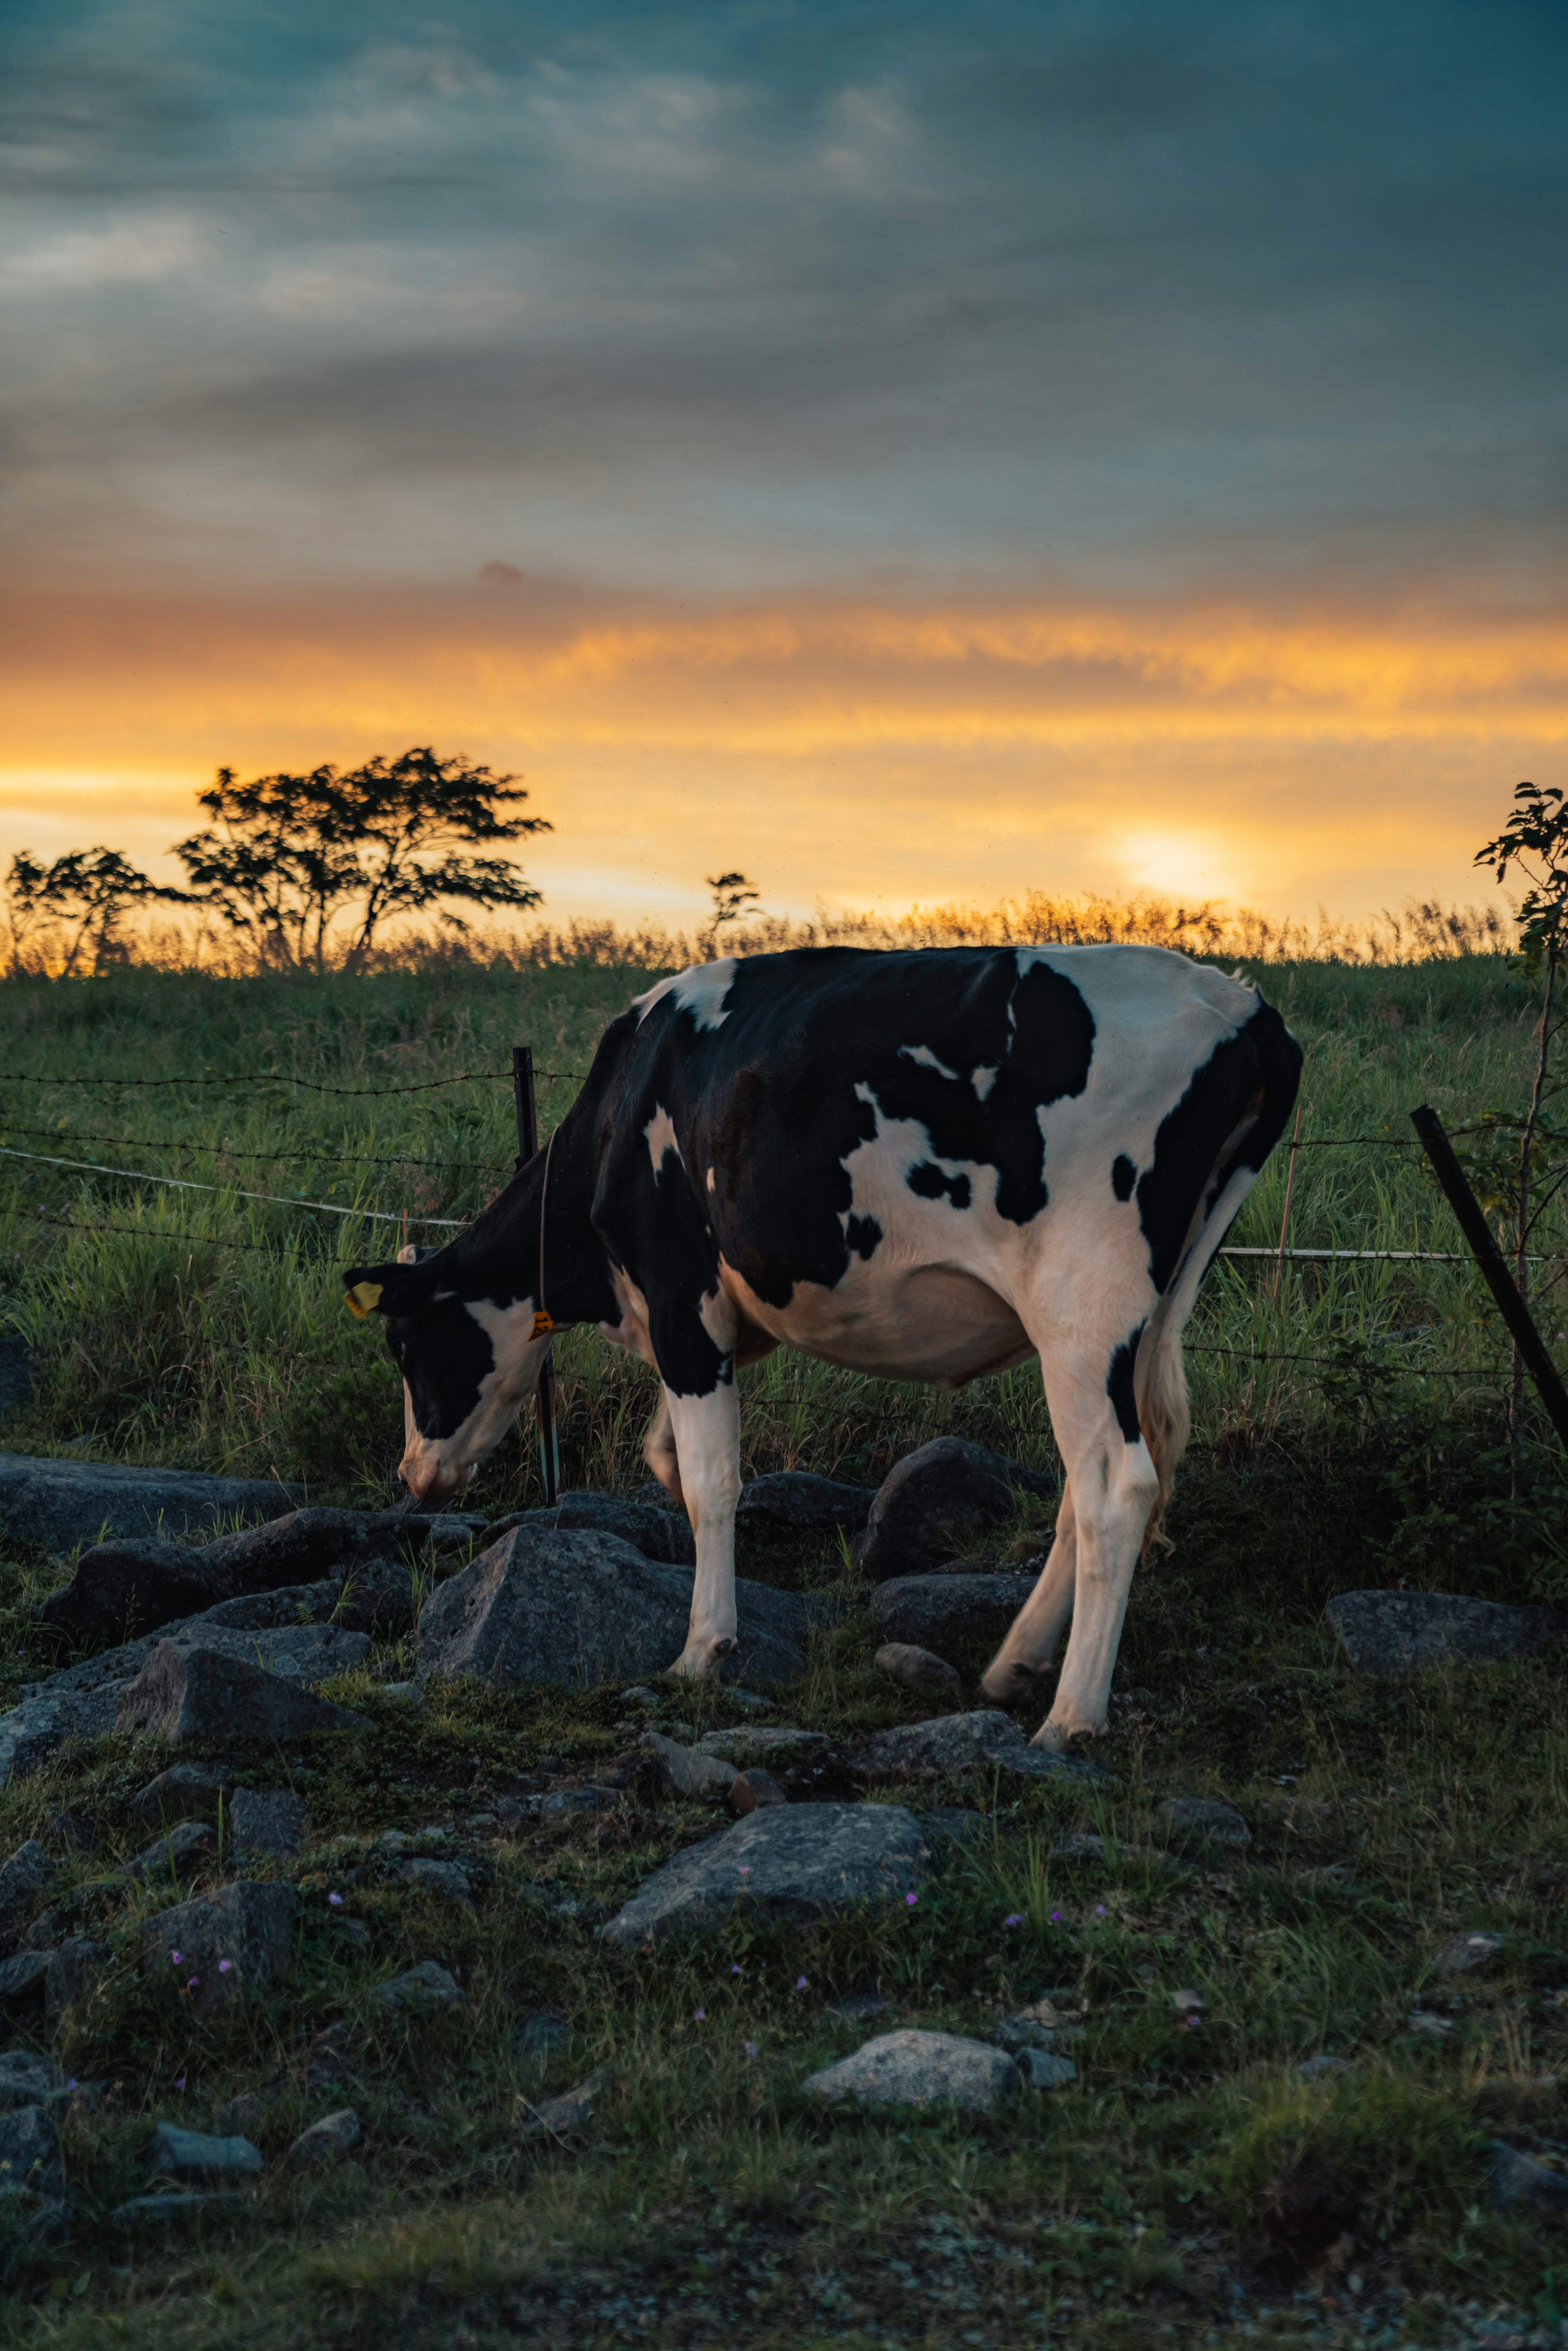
[343,947,1302,1747]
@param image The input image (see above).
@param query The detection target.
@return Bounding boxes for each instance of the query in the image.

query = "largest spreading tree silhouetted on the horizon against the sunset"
[174,745,552,971]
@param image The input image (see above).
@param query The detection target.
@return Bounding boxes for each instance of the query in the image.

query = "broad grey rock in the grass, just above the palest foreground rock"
[602,1803,931,1949]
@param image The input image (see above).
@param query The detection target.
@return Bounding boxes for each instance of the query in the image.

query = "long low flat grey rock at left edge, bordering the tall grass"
[0,1453,303,1552]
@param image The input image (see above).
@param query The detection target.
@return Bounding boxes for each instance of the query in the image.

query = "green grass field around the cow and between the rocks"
[0,957,1568,2351]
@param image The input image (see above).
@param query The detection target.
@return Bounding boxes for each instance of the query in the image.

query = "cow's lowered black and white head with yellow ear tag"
[343,1248,550,1502]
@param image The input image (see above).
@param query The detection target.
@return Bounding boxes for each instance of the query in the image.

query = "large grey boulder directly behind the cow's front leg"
[419,1526,811,1688]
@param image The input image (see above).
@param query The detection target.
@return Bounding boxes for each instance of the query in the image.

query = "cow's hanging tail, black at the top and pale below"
[1133,1001,1302,1559]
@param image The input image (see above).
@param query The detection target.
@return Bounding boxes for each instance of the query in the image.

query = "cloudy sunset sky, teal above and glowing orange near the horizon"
[0,0,1568,922]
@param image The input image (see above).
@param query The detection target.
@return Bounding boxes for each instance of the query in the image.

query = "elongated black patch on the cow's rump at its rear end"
[1138,1004,1302,1298]
